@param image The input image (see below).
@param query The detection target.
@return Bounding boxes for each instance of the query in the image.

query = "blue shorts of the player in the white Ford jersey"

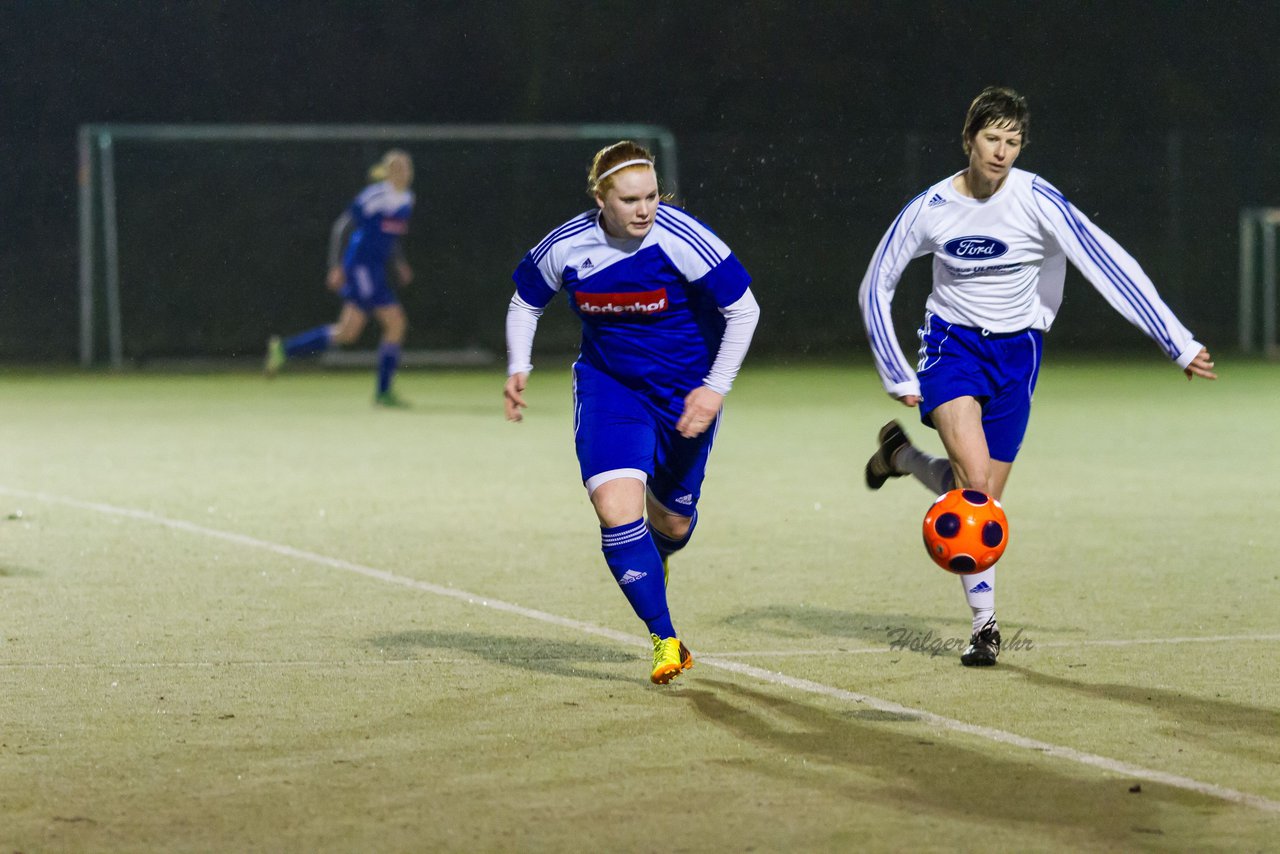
[916,312,1044,462]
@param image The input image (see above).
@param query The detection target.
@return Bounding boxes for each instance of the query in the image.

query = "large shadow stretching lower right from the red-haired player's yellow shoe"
[680,676,1230,849]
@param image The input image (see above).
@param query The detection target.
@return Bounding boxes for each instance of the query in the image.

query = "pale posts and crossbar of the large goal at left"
[78,124,678,369]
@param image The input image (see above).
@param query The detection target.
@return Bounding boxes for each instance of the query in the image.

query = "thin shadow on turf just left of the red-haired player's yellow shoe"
[370,631,641,682]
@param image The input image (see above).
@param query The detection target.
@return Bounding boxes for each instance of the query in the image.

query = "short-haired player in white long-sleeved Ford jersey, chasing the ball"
[858,87,1216,666]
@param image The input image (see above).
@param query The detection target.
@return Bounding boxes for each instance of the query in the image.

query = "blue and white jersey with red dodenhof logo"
[512,204,754,398]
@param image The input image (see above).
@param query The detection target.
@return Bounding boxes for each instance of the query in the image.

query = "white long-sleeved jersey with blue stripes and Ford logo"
[858,169,1201,397]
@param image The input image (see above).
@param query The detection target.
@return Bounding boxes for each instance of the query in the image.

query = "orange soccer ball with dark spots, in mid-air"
[924,489,1009,575]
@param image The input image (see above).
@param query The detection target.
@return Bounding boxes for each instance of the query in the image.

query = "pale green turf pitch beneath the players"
[0,358,1280,853]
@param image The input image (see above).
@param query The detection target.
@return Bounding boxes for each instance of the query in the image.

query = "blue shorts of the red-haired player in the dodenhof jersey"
[573,362,719,516]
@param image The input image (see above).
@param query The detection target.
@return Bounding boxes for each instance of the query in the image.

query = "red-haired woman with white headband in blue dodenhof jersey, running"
[503,141,760,684]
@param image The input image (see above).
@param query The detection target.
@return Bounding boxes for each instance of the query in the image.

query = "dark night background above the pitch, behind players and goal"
[0,0,1280,364]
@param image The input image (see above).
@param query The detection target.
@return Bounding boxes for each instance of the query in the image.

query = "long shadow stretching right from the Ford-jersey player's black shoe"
[1001,662,1280,762]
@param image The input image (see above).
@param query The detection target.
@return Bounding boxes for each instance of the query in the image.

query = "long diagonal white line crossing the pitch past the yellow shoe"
[0,485,1280,814]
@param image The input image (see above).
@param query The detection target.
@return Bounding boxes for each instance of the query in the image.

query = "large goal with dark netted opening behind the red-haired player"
[79,124,677,367]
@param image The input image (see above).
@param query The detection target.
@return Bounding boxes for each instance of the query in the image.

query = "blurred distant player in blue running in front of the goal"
[266,149,413,406]
